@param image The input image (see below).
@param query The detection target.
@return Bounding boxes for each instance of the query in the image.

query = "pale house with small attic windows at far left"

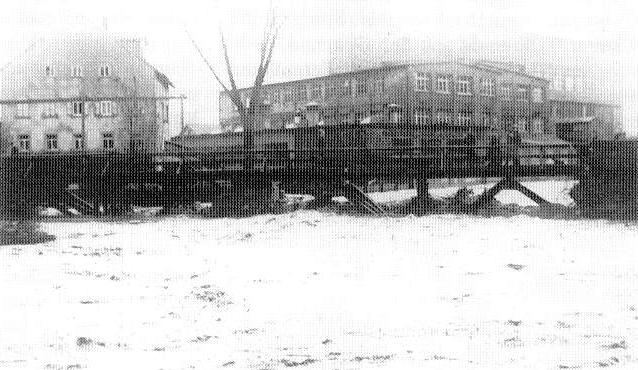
[0,34,173,152]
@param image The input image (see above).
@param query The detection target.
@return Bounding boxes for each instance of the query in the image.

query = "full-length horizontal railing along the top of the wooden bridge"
[0,144,580,176]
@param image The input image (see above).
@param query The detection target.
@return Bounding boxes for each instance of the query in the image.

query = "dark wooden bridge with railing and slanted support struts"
[1,145,585,217]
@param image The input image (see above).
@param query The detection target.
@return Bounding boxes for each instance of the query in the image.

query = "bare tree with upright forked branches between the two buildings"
[189,10,279,165]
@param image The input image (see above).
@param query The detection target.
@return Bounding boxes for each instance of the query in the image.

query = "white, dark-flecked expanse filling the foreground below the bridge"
[0,183,638,369]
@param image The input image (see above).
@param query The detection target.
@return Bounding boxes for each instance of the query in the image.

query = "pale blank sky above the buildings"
[0,0,638,135]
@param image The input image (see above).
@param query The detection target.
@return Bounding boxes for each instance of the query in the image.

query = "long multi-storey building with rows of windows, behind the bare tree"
[219,62,555,143]
